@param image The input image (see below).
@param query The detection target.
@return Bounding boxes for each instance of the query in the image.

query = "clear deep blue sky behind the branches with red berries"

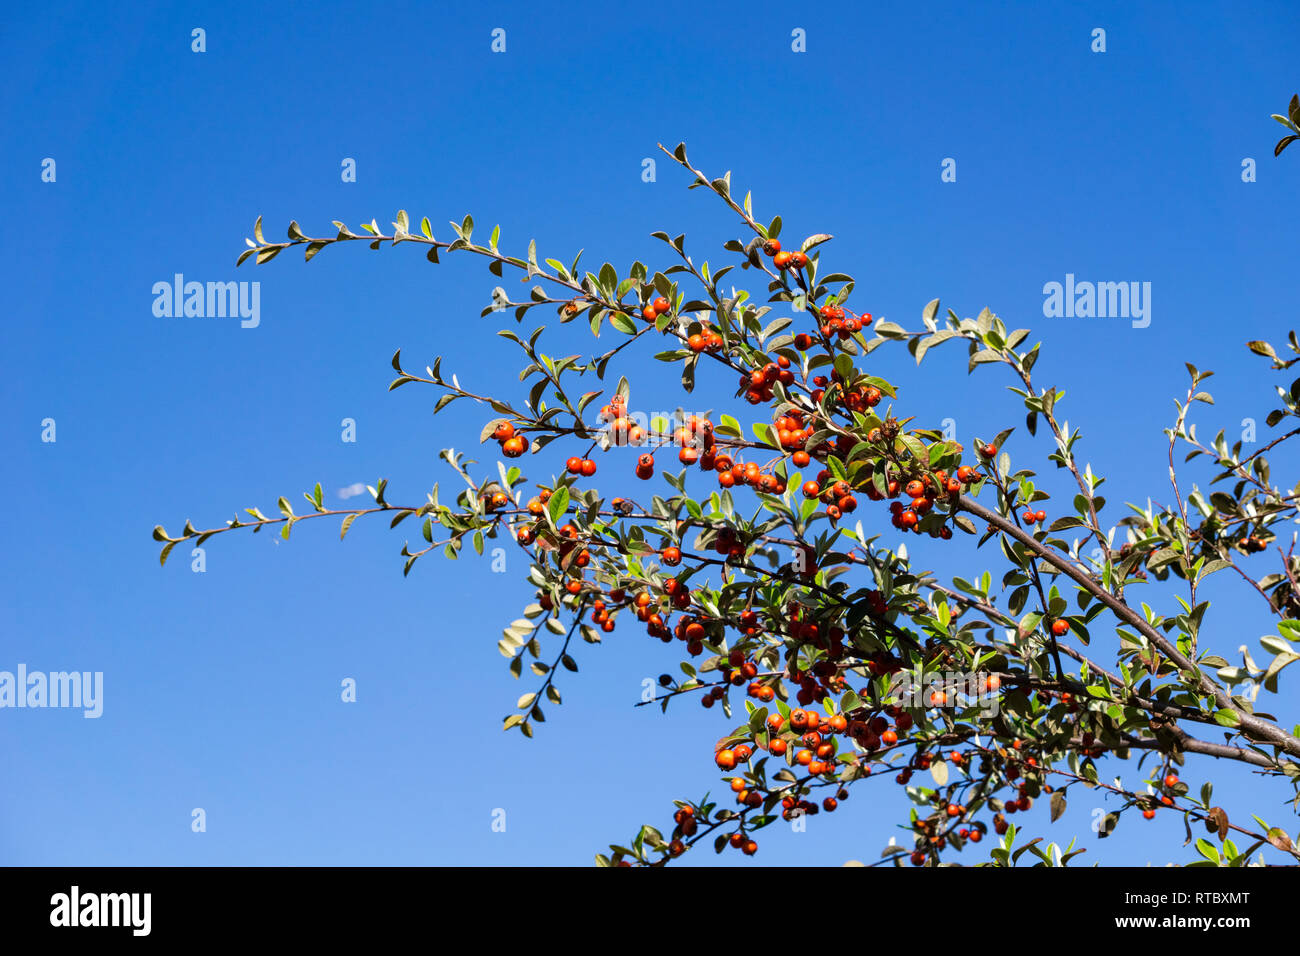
[0,1,1300,865]
